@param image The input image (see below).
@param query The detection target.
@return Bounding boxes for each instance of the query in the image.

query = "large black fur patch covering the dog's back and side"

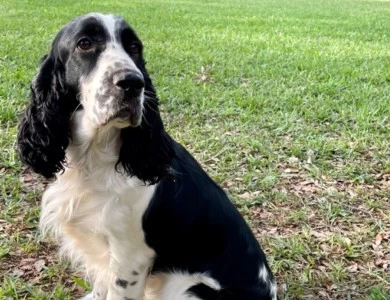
[143,141,274,300]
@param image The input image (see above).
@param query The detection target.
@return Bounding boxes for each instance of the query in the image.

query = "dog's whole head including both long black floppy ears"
[18,13,172,182]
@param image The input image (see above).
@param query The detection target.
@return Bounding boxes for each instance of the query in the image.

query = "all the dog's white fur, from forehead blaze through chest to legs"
[40,14,220,300]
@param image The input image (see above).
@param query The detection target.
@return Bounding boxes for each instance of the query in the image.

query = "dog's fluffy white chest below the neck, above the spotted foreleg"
[41,169,155,274]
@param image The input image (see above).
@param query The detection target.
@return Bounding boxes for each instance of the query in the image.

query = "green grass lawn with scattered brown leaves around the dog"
[0,0,390,300]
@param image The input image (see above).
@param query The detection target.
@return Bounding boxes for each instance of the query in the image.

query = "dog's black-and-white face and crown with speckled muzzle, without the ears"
[51,14,145,127]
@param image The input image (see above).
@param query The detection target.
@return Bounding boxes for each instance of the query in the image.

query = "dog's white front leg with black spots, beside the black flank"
[107,240,154,300]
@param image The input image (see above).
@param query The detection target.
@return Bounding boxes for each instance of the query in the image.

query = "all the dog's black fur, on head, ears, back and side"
[18,14,274,300]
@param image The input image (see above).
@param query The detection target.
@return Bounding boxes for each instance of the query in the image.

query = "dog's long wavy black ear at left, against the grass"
[18,51,71,178]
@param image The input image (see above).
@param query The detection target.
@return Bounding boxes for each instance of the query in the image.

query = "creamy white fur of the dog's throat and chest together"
[41,111,155,299]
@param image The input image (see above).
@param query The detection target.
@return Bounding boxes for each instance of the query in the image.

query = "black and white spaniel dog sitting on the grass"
[18,13,276,300]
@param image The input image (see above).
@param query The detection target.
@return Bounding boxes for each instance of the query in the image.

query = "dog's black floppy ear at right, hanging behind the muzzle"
[118,61,175,184]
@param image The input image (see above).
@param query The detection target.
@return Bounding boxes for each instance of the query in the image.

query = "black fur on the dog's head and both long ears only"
[18,17,174,184]
